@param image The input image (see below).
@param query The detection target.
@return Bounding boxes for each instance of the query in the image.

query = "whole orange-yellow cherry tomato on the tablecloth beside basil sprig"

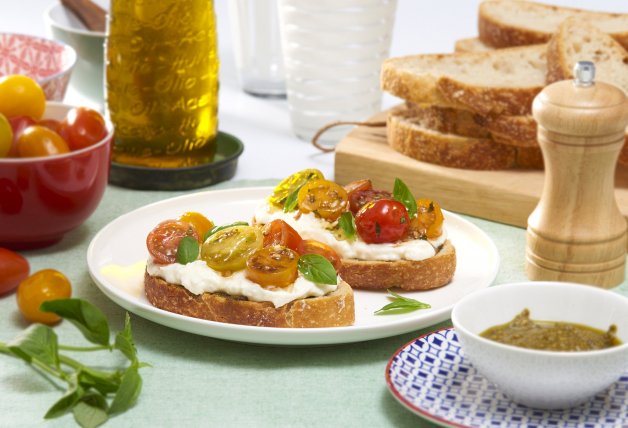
[17,269,72,324]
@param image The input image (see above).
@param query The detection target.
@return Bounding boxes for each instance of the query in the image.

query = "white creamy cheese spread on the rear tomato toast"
[255,202,447,261]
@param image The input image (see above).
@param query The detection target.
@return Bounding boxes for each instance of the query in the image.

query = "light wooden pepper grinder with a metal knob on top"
[526,61,628,288]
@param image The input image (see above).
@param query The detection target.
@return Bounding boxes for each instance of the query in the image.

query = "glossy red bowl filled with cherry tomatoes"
[0,102,113,249]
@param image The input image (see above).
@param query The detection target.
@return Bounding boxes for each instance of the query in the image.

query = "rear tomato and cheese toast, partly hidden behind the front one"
[253,169,456,291]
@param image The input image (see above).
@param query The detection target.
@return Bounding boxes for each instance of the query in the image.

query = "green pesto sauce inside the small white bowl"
[480,309,621,352]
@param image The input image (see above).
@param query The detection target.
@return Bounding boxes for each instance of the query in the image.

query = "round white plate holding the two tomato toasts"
[87,187,499,346]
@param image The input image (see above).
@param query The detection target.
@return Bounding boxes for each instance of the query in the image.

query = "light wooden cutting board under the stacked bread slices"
[334,112,628,228]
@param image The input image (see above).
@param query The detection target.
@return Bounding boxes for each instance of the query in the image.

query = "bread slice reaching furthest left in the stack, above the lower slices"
[381,46,547,115]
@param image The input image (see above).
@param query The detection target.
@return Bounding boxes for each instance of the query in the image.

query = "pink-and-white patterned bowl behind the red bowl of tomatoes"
[0,33,76,101]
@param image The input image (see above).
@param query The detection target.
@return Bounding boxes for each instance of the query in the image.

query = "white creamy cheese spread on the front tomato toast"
[146,259,338,308]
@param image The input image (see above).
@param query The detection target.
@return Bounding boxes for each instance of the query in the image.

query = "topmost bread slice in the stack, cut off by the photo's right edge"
[478,0,628,48]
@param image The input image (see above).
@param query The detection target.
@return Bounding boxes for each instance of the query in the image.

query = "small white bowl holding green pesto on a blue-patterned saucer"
[451,282,628,409]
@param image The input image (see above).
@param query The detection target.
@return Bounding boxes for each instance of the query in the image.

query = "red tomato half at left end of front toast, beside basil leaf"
[146,220,198,264]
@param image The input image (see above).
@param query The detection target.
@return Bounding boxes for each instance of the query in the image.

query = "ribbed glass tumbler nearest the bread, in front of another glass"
[279,0,397,143]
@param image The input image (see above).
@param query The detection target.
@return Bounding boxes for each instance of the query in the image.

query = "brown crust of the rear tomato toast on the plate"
[340,240,456,291]
